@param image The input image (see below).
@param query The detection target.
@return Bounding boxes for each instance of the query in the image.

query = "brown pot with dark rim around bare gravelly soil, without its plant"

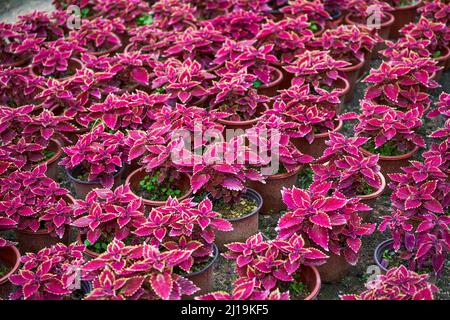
[215,188,263,252]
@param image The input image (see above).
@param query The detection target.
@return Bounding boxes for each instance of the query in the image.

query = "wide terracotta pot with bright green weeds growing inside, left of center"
[125,168,192,212]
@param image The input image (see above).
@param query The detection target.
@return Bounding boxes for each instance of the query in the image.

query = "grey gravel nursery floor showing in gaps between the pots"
[0,0,450,300]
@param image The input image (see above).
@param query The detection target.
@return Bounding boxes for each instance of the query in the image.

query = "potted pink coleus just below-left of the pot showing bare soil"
[134,198,232,294]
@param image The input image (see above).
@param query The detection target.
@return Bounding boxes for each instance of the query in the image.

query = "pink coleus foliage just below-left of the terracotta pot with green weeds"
[72,185,145,251]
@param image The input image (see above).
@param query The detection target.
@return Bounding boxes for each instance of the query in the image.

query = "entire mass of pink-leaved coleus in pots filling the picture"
[0,0,450,300]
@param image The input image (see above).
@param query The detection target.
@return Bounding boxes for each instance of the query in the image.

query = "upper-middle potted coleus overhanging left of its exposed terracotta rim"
[214,39,283,97]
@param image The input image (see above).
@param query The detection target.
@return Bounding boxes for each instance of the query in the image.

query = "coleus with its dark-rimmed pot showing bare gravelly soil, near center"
[187,136,264,251]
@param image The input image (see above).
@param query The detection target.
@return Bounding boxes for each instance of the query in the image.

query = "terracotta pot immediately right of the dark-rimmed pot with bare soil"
[249,166,302,215]
